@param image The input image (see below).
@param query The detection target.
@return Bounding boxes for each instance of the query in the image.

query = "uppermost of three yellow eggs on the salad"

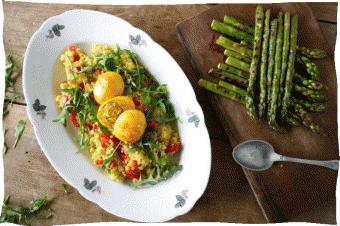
[93,71,124,104]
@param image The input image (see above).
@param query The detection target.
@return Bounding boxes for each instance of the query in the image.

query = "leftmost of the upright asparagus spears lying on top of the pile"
[246,5,264,119]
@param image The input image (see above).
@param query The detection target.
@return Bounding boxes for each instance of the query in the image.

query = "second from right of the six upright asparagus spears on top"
[278,12,290,108]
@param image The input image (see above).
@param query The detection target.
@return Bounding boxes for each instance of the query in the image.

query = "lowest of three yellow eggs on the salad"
[113,110,146,144]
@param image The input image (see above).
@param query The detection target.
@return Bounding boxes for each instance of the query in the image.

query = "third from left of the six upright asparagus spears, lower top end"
[267,19,277,115]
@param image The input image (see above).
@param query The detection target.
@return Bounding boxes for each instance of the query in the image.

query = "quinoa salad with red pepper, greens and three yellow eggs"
[53,44,182,187]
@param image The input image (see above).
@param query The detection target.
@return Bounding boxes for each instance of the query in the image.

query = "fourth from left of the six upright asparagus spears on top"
[268,12,283,129]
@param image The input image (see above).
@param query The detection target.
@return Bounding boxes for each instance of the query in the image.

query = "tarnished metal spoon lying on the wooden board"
[233,140,339,171]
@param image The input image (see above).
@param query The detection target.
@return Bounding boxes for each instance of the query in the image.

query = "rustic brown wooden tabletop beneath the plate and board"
[3,2,337,225]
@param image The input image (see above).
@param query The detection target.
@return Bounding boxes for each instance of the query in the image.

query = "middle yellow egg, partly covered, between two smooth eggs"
[97,96,135,129]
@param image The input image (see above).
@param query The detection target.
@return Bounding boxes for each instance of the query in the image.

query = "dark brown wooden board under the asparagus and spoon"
[177,3,339,222]
